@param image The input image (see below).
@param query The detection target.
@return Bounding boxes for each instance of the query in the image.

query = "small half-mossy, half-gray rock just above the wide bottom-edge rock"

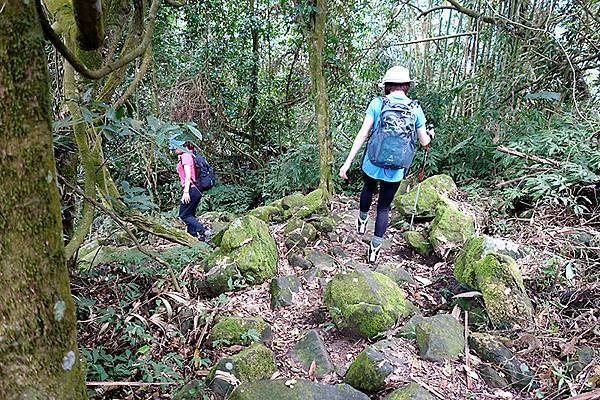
[344,346,394,393]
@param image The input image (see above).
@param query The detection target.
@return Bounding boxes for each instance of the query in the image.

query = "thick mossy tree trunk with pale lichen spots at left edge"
[0,0,87,400]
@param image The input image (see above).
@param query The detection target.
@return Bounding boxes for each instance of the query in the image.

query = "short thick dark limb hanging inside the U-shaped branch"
[73,0,104,51]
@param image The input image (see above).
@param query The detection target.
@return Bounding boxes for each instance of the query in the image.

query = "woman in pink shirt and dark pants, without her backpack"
[169,139,208,240]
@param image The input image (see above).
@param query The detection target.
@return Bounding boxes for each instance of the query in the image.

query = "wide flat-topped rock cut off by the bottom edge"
[229,379,369,400]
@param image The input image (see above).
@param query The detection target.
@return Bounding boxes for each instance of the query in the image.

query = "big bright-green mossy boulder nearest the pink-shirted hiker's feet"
[207,215,278,294]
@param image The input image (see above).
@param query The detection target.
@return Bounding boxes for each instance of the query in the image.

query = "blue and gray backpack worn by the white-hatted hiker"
[367,97,419,171]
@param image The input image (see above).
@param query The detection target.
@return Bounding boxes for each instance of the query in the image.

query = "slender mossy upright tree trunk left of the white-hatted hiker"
[307,0,333,199]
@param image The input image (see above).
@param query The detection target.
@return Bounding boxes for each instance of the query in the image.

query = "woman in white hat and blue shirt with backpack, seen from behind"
[339,66,431,263]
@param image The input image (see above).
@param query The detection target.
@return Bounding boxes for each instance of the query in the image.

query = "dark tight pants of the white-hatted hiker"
[360,172,400,237]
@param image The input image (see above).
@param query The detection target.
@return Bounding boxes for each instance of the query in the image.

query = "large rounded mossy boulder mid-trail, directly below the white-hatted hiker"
[324,270,414,338]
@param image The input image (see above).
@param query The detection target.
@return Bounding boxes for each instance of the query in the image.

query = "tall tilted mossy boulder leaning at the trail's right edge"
[454,236,533,328]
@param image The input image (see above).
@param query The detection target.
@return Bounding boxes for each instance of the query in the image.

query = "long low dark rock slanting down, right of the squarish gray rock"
[469,332,534,388]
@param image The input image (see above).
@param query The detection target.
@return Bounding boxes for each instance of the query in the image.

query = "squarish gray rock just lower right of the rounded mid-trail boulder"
[415,314,465,362]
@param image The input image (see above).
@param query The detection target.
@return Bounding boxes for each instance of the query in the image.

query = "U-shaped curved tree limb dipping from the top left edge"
[35,0,160,80]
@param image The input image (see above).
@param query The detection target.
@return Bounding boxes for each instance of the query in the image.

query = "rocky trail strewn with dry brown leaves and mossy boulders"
[76,176,598,400]
